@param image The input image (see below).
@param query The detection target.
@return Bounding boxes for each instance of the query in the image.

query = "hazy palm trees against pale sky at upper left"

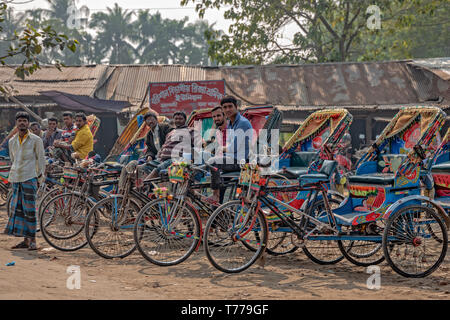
[0,0,213,65]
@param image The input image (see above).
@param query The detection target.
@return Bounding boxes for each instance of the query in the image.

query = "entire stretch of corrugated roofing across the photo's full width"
[0,58,450,108]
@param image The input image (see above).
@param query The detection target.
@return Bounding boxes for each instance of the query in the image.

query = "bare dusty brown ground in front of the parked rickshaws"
[0,210,450,300]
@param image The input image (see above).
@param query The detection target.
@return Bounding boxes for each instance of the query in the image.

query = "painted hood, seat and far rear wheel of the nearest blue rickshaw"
[335,107,445,266]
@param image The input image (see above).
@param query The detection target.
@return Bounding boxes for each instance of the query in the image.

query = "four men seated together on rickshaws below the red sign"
[144,96,252,205]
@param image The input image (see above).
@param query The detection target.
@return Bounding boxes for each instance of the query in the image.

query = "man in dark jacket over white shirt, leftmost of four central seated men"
[144,112,171,162]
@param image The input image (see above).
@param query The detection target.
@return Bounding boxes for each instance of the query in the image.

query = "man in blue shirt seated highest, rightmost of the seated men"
[207,96,253,205]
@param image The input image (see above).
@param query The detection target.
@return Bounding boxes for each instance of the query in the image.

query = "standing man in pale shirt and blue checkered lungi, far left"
[5,112,45,250]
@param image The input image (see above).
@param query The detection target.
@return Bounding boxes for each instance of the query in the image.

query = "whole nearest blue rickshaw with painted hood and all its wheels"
[203,107,450,278]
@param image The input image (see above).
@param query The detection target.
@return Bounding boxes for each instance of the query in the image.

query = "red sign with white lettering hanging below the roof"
[149,80,225,116]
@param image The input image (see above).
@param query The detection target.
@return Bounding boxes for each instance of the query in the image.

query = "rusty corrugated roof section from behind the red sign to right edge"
[96,61,450,106]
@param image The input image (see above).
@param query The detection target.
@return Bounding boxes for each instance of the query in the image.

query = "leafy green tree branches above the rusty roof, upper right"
[181,0,448,64]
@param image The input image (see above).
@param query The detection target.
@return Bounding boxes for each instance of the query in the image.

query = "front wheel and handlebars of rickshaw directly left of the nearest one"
[134,163,243,266]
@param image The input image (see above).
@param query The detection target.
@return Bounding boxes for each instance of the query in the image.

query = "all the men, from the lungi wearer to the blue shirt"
[1,96,252,250]
